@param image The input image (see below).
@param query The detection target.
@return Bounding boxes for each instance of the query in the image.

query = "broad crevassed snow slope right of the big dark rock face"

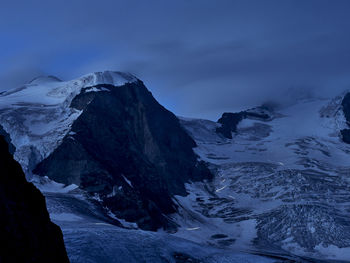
[179,96,350,261]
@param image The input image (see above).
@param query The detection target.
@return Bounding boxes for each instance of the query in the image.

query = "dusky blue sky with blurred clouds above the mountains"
[0,0,350,119]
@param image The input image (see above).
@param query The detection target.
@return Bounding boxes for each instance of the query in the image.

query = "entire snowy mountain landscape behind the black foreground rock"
[0,71,350,262]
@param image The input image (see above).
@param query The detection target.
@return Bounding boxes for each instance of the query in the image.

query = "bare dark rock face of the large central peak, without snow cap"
[33,80,212,230]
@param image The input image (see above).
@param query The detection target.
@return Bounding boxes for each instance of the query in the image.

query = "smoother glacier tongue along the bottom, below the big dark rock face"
[45,192,276,263]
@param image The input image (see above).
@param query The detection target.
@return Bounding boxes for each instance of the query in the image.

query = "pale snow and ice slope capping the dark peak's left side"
[0,71,137,178]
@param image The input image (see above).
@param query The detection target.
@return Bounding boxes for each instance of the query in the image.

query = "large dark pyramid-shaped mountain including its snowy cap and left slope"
[0,71,212,230]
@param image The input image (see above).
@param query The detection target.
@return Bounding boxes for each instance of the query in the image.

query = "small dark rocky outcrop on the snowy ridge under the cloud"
[216,103,275,139]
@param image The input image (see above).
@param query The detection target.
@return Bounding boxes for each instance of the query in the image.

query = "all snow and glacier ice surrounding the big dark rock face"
[0,71,350,263]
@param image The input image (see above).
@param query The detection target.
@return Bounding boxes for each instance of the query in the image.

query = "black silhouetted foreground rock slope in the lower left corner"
[0,136,69,263]
